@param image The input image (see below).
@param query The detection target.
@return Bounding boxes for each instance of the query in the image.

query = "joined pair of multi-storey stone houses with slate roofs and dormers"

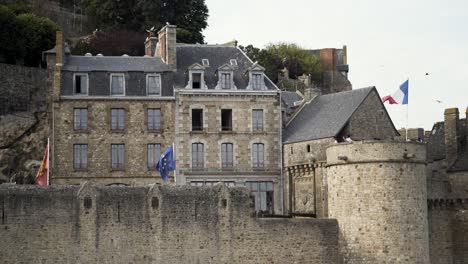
[45,25,283,213]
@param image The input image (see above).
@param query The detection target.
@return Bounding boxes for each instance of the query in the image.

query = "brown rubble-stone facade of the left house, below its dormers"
[51,98,175,186]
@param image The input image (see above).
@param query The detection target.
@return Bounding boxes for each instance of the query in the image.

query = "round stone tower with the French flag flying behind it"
[326,141,430,263]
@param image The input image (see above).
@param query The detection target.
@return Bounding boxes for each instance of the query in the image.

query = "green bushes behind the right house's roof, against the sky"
[240,42,323,83]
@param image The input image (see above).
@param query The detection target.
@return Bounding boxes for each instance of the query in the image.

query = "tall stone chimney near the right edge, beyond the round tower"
[444,108,460,167]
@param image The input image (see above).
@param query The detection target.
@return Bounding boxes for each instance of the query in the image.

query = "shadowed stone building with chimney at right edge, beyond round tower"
[427,108,468,263]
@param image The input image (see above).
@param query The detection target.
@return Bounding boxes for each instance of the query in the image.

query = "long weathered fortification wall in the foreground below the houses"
[0,185,338,263]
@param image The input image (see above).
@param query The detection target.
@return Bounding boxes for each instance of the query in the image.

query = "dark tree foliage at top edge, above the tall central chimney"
[82,0,208,43]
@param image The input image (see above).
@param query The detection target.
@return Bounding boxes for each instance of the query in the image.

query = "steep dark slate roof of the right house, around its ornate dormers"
[173,43,277,90]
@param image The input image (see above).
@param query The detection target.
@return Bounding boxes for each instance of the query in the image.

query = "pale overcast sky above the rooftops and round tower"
[203,0,468,130]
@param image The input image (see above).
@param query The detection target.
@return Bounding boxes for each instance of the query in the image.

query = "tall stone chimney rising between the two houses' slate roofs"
[156,25,177,70]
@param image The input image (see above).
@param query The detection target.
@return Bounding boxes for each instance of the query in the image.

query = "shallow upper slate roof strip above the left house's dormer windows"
[63,56,170,72]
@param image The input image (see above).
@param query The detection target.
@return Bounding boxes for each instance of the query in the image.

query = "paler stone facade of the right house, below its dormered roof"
[176,89,283,213]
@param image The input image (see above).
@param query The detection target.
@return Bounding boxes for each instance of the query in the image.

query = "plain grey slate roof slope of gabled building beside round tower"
[283,87,375,143]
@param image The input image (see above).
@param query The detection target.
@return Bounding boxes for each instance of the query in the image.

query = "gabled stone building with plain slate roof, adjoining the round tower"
[283,87,399,217]
